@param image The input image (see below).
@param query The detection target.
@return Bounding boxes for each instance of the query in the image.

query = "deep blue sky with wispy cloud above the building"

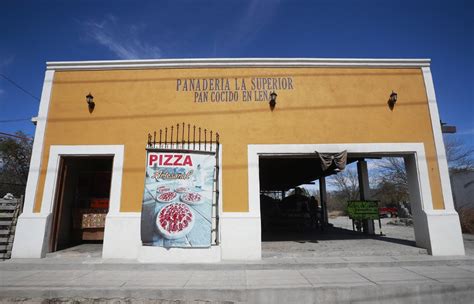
[0,0,474,147]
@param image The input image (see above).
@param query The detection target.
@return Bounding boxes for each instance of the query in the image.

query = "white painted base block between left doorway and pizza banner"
[102,212,142,259]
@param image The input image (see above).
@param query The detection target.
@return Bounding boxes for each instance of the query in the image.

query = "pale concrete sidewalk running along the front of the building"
[0,255,474,303]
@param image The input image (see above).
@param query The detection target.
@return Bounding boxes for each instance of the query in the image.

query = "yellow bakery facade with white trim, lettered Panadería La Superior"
[13,59,464,262]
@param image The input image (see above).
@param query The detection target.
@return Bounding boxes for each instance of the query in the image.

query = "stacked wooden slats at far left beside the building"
[0,198,23,260]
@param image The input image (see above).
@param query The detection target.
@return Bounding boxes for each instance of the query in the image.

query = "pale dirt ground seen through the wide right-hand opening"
[262,216,474,258]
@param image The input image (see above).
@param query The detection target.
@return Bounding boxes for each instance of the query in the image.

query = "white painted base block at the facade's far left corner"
[12,213,52,259]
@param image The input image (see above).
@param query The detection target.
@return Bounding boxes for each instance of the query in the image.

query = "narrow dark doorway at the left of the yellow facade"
[50,156,113,252]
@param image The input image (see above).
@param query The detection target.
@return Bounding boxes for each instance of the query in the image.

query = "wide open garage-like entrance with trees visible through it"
[259,153,418,258]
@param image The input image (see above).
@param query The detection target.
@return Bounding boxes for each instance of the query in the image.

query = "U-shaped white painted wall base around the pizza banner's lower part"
[102,213,262,263]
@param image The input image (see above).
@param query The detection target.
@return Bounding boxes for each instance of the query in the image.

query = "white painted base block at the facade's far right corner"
[426,210,465,256]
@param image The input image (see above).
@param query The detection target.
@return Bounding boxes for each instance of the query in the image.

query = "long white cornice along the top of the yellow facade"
[46,58,431,70]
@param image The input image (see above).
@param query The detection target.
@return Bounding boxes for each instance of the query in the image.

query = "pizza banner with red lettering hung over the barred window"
[141,150,216,248]
